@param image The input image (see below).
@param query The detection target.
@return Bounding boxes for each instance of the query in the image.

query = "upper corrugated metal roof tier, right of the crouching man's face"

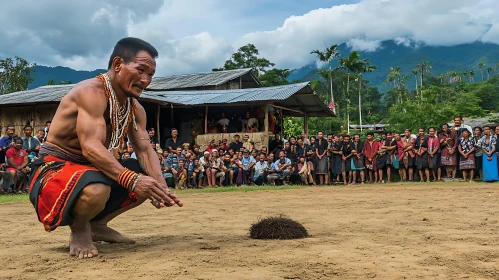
[147,68,252,90]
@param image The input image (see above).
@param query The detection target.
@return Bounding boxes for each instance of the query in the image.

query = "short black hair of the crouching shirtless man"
[107,37,158,69]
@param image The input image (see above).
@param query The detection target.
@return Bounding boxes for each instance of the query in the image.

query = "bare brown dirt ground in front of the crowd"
[0,183,499,280]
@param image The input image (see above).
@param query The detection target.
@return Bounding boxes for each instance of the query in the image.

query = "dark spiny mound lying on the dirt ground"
[250,215,308,239]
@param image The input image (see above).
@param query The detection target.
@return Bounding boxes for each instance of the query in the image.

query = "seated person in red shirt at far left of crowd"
[5,137,29,193]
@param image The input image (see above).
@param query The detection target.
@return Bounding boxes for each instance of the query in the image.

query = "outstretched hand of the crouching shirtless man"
[134,175,184,208]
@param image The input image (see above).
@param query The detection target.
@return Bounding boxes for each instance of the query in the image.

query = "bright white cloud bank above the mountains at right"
[237,0,499,68]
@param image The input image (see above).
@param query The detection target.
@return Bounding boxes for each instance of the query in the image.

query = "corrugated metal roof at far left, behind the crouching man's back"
[0,84,74,105]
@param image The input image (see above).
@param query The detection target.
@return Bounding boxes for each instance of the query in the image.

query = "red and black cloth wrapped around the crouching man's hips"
[29,144,143,231]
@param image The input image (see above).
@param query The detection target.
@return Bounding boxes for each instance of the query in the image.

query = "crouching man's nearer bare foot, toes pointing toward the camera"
[69,223,99,259]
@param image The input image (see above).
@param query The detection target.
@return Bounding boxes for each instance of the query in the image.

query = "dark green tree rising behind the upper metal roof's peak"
[213,44,275,76]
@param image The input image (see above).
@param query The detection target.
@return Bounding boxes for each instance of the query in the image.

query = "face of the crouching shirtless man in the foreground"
[111,51,156,98]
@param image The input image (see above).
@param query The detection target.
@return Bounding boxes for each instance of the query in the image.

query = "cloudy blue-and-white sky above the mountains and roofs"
[0,0,499,75]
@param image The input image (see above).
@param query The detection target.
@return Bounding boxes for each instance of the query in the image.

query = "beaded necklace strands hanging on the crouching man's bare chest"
[97,73,137,152]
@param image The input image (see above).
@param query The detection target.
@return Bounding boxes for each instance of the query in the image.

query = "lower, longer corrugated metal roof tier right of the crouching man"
[141,82,309,105]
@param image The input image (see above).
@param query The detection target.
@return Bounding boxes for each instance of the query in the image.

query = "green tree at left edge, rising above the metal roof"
[0,56,36,94]
